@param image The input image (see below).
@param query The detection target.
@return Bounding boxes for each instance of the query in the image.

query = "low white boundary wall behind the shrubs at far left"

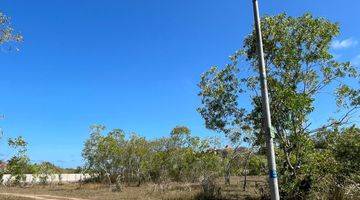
[3,174,90,184]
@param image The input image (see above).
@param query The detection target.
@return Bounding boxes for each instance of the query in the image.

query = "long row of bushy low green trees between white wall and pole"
[83,126,222,188]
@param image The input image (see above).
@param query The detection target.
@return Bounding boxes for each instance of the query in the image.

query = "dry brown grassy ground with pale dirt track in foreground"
[0,177,266,200]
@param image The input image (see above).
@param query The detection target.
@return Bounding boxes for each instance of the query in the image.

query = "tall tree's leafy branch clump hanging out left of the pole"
[198,61,244,141]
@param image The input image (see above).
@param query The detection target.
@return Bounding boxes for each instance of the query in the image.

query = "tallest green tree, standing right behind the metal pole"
[199,14,360,198]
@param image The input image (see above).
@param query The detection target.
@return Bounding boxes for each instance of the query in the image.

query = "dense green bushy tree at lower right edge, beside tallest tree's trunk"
[300,126,360,199]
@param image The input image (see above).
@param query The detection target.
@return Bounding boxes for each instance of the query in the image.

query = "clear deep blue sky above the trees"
[0,0,360,166]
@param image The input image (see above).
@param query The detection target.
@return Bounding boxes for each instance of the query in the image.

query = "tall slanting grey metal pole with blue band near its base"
[253,0,280,200]
